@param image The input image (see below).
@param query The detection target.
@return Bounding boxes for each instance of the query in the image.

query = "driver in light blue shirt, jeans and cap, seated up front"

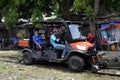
[50,30,66,59]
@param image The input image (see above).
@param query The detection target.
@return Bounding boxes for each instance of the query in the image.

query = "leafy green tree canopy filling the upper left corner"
[0,0,54,29]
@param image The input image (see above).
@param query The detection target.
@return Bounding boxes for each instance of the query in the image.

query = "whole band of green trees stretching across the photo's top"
[0,0,120,28]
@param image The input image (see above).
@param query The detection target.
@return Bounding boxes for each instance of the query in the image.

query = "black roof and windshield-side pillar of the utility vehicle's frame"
[35,21,83,43]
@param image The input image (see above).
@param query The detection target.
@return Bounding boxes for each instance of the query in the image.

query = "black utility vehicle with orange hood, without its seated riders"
[22,21,99,71]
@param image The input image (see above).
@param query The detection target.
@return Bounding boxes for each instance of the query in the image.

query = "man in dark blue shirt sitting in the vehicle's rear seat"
[32,30,43,50]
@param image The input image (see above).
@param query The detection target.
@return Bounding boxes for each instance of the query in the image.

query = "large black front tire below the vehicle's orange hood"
[68,56,85,72]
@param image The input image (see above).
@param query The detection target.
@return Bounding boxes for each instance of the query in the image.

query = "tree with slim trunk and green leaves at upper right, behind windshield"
[74,0,120,32]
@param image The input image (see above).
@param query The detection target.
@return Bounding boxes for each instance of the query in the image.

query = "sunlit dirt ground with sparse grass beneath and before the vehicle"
[0,51,120,80]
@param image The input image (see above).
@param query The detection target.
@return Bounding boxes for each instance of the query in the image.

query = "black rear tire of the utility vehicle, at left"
[23,52,33,65]
